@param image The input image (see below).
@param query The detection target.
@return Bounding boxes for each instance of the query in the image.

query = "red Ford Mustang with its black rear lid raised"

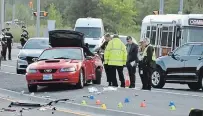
[26,30,103,92]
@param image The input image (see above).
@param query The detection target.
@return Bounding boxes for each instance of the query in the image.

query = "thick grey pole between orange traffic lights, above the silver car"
[36,0,40,37]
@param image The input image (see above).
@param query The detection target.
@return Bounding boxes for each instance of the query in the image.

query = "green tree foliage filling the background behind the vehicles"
[4,0,203,38]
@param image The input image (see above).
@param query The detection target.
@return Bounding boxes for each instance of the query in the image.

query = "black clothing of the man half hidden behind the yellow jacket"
[101,41,112,86]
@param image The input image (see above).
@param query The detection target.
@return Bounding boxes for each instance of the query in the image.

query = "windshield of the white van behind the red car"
[75,27,101,38]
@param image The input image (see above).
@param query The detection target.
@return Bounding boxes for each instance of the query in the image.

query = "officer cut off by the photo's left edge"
[1,29,7,60]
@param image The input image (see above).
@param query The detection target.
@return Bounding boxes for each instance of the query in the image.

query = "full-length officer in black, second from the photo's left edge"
[5,28,13,60]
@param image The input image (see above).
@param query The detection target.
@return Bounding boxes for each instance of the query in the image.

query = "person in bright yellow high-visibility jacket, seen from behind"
[104,35,127,87]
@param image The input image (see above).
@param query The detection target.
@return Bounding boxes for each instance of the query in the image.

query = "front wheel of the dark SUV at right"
[151,68,166,88]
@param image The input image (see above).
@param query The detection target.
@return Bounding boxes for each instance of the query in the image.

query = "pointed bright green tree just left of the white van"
[48,3,63,27]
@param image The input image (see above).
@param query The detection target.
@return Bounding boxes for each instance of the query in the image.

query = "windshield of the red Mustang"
[38,48,83,60]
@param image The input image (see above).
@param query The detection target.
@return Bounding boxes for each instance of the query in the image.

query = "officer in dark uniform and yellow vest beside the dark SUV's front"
[142,38,156,90]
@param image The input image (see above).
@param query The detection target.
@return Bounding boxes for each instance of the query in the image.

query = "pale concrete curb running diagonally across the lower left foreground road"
[0,88,150,116]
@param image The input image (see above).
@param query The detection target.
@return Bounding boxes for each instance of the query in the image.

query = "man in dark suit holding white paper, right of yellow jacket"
[126,36,138,88]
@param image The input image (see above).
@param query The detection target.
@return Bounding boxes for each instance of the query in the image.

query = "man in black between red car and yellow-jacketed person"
[100,33,112,86]
